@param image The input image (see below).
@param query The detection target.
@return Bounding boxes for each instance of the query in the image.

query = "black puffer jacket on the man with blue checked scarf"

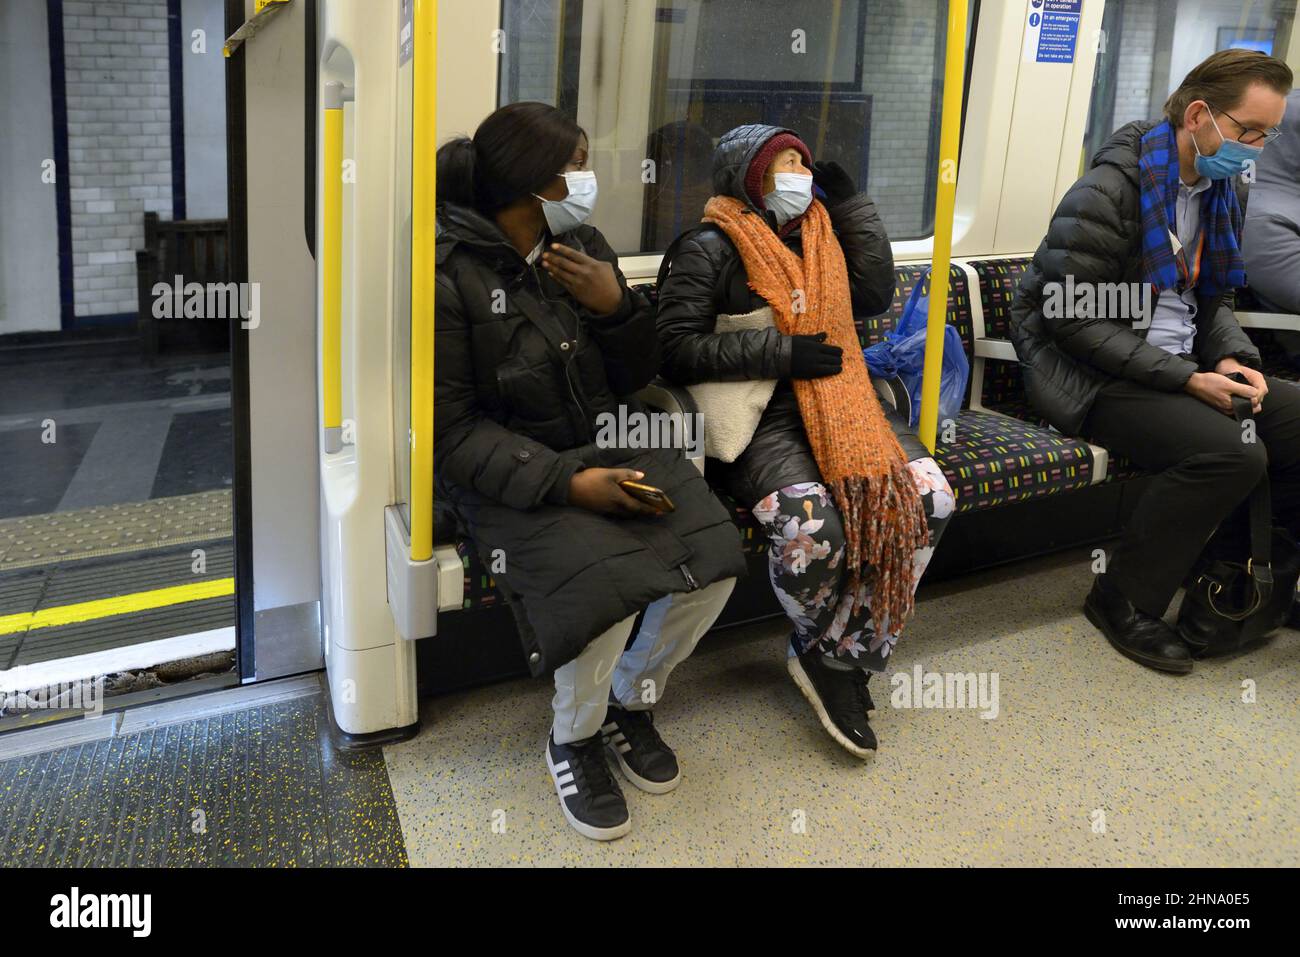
[1011,122,1260,436]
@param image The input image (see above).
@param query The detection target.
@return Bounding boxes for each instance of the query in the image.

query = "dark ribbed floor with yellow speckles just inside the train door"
[0,694,407,867]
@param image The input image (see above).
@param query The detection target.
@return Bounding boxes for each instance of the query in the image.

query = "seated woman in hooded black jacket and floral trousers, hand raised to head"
[658,124,954,757]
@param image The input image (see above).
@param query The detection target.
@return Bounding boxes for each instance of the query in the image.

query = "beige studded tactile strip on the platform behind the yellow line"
[0,490,231,571]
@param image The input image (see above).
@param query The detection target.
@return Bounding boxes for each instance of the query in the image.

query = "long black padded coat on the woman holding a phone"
[433,204,745,675]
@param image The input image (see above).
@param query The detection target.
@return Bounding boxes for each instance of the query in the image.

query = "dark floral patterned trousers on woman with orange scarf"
[753,458,956,671]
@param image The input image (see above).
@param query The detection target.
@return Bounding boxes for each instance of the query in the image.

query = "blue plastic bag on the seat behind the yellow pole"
[862,273,971,424]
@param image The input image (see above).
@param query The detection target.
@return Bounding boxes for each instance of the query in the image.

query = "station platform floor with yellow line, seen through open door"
[0,341,235,702]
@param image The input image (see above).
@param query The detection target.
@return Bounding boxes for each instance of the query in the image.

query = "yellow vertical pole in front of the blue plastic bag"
[919,0,967,454]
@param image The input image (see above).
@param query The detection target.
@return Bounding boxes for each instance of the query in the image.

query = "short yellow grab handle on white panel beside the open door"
[321,82,343,452]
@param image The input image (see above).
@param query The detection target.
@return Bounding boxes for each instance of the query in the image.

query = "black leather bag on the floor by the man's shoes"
[1178,397,1300,658]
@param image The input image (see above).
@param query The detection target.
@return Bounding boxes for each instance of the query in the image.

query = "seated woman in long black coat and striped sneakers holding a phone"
[434,103,744,840]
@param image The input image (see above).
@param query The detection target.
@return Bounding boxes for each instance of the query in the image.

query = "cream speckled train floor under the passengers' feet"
[385,551,1300,866]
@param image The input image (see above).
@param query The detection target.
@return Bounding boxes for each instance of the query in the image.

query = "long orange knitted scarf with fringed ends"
[703,196,930,635]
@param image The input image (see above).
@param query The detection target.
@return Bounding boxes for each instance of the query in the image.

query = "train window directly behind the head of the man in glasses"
[1084,0,1296,165]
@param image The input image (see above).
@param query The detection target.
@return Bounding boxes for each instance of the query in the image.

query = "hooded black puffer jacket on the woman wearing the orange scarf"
[658,124,928,506]
